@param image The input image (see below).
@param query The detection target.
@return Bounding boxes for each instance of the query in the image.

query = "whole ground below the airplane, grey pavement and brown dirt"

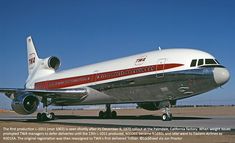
[0,106,235,143]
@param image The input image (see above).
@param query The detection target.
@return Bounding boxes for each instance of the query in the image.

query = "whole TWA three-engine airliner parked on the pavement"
[0,36,230,121]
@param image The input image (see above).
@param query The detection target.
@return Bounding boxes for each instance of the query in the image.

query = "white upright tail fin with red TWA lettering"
[27,36,39,76]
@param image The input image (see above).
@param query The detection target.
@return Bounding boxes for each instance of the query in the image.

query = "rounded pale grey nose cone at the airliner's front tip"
[213,68,230,86]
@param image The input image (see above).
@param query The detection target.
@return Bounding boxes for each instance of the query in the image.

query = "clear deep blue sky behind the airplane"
[0,0,235,108]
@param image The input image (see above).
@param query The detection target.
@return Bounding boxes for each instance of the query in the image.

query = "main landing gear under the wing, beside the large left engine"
[37,98,55,121]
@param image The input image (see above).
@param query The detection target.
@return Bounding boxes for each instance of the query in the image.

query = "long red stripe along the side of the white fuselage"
[35,63,183,89]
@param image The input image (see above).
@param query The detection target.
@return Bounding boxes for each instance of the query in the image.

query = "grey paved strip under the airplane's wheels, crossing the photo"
[0,115,235,131]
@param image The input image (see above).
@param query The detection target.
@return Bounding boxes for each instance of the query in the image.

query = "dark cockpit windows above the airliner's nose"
[190,59,219,67]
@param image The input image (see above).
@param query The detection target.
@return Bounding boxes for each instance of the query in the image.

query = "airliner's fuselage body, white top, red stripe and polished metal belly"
[26,49,229,105]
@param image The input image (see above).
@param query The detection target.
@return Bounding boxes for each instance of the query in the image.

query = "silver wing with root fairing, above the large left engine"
[0,87,117,106]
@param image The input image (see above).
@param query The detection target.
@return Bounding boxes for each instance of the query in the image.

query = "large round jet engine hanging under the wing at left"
[11,93,39,115]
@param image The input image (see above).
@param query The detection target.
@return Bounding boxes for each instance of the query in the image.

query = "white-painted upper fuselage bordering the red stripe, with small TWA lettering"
[31,49,215,89]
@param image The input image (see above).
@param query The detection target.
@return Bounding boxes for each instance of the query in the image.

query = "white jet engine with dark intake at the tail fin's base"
[43,56,60,70]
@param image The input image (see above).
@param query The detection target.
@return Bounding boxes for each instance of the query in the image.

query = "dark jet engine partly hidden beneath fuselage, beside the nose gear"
[137,100,176,111]
